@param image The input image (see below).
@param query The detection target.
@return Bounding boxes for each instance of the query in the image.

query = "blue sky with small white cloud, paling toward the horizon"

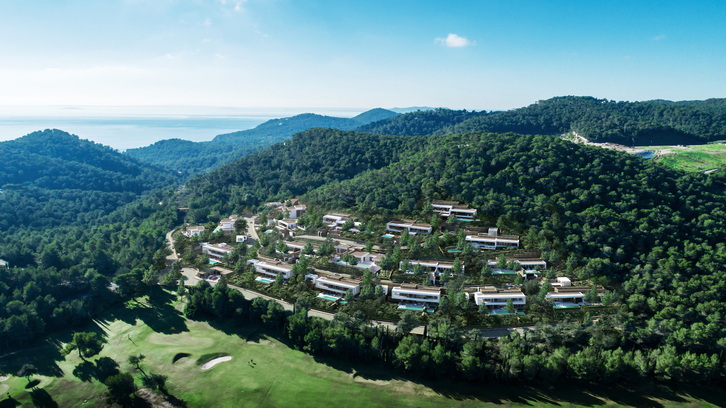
[0,0,726,111]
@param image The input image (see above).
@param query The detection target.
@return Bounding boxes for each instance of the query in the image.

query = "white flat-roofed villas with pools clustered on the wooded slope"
[183,200,604,315]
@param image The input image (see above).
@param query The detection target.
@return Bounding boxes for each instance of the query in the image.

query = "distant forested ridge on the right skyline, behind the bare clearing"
[357,96,726,145]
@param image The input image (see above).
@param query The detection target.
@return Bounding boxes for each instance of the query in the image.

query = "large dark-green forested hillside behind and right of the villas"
[303,134,726,362]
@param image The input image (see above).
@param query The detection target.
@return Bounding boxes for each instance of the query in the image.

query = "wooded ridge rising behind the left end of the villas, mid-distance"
[182,128,423,222]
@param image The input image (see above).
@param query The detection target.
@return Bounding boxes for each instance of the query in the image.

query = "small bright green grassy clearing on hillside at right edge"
[651,143,726,171]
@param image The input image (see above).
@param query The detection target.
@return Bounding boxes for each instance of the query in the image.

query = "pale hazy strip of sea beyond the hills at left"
[0,106,366,151]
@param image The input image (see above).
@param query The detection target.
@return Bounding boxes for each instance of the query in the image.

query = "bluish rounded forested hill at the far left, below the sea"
[0,130,180,233]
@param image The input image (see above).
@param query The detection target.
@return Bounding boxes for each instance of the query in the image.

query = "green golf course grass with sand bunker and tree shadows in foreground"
[0,292,726,408]
